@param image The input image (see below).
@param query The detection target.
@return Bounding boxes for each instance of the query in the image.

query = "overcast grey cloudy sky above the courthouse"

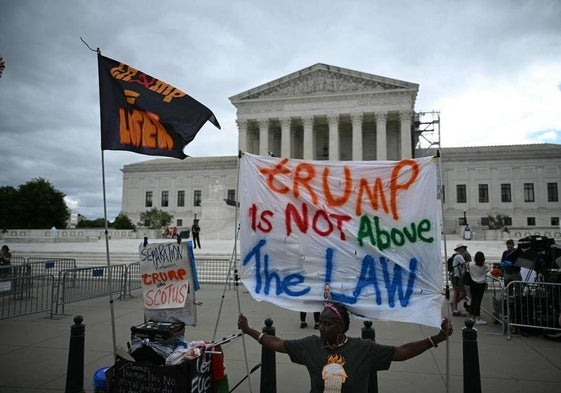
[0,0,561,220]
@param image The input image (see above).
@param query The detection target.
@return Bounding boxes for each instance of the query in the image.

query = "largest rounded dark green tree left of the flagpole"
[12,178,70,229]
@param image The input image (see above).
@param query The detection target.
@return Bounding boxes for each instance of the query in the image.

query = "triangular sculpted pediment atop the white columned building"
[230,64,419,103]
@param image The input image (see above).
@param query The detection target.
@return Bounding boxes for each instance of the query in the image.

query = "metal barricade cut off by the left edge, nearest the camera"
[0,274,55,319]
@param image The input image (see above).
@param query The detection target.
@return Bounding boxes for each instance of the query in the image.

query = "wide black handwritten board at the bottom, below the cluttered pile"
[108,357,192,393]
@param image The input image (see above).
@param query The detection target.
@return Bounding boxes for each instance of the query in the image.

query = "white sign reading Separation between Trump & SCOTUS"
[139,242,197,325]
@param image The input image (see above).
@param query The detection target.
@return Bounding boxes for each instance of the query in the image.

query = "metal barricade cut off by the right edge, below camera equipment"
[505,281,561,340]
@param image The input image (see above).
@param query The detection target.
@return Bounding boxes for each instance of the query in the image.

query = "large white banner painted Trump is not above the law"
[240,153,443,327]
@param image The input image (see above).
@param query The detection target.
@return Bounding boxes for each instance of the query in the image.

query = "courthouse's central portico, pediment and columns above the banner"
[230,64,419,161]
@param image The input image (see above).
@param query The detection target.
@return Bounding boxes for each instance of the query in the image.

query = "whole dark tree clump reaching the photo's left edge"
[0,178,70,229]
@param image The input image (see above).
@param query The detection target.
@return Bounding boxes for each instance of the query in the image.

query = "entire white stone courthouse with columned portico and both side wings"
[122,64,561,241]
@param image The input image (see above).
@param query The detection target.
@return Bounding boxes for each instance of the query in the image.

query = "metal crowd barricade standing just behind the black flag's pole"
[55,265,126,314]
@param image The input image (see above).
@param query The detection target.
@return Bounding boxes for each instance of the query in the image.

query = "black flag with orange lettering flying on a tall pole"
[98,54,220,158]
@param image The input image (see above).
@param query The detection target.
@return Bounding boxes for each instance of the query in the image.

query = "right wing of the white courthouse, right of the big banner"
[426,144,561,240]
